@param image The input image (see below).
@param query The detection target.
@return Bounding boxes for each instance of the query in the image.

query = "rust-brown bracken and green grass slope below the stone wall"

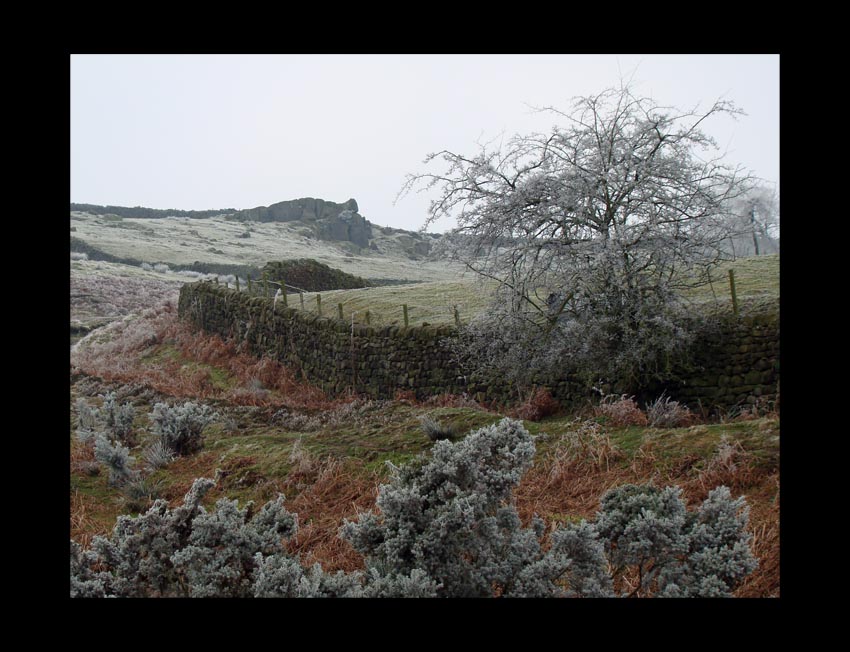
[70,305,780,597]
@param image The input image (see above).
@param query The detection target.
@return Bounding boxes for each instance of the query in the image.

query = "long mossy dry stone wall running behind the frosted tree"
[179,282,779,409]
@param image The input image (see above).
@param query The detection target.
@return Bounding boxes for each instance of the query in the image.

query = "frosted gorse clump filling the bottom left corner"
[70,478,344,597]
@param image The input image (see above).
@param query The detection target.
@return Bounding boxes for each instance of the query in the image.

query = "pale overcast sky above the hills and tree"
[71,55,779,230]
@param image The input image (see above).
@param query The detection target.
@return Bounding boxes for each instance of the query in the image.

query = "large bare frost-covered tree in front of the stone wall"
[401,86,751,391]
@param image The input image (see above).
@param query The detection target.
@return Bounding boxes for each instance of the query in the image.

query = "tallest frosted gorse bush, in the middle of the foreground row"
[340,419,559,597]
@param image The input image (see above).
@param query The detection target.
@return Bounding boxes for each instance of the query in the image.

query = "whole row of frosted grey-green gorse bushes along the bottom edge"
[71,419,756,597]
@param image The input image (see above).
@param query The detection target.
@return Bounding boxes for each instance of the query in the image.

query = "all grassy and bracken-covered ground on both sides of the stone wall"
[69,202,780,597]
